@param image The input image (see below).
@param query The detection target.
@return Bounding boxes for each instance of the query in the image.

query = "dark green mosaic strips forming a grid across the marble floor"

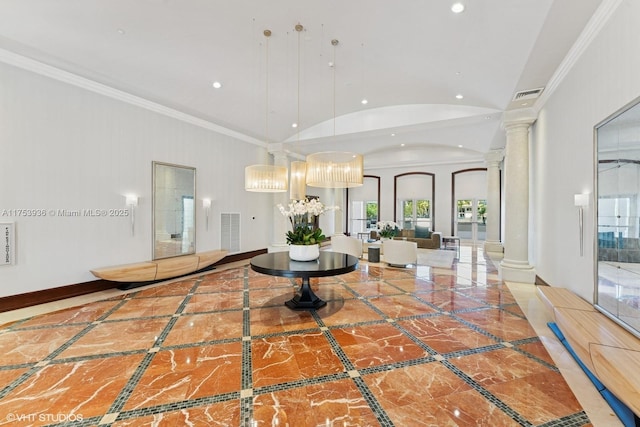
[0,256,589,427]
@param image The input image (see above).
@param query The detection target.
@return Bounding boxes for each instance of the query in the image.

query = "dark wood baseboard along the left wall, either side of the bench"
[0,249,267,313]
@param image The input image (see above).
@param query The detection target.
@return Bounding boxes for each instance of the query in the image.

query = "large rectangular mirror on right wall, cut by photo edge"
[594,99,640,337]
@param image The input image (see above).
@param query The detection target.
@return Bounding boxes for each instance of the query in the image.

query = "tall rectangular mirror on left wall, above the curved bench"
[153,162,196,259]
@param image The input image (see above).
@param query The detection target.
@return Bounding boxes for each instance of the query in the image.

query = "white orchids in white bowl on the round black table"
[278,199,335,261]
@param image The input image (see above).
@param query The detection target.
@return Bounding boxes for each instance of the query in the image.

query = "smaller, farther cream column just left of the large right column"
[484,150,504,253]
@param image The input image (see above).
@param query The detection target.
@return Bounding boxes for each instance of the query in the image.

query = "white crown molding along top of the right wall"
[533,0,623,113]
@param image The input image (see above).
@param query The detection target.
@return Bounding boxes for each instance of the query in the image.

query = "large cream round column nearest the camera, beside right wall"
[500,109,536,283]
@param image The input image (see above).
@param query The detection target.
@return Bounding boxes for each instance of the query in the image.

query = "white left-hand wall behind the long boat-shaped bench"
[0,63,273,296]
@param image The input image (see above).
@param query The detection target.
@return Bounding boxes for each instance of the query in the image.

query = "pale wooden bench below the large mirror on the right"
[538,286,640,415]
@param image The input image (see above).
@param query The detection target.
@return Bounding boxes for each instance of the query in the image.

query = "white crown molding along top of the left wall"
[0,49,266,147]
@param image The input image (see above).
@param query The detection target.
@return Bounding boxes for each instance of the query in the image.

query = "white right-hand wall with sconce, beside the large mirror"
[532,0,640,301]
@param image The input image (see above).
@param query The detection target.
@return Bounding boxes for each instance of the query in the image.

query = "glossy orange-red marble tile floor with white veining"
[0,246,620,427]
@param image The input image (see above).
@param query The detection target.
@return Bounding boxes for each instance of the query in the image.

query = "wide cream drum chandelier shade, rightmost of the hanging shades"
[307,151,364,188]
